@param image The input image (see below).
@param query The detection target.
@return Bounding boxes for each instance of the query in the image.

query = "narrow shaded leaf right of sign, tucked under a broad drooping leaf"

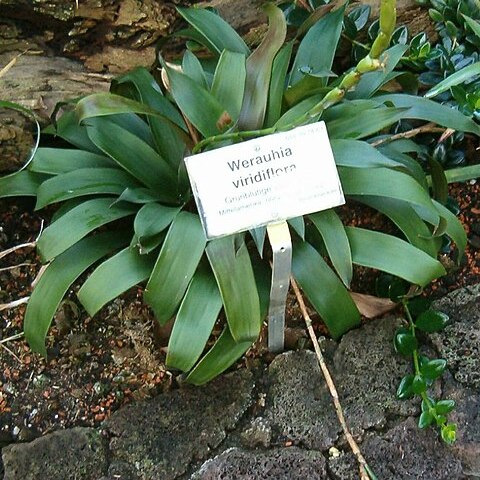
[353,195,437,258]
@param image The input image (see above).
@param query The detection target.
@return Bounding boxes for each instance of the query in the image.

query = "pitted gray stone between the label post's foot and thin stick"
[265,351,340,450]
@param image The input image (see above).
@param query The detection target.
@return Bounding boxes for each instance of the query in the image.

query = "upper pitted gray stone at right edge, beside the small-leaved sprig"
[431,285,480,390]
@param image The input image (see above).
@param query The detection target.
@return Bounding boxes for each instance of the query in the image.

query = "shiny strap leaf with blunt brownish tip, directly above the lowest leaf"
[166,266,222,372]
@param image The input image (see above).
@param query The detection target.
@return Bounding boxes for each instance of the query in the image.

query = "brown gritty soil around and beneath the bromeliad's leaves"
[0,169,480,445]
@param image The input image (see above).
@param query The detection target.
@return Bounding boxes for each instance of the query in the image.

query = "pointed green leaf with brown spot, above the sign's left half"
[164,65,232,137]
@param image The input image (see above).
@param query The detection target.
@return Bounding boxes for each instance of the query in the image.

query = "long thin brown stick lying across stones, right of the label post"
[290,278,371,480]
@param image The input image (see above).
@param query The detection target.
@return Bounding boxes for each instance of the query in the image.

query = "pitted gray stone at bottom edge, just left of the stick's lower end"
[192,447,328,480]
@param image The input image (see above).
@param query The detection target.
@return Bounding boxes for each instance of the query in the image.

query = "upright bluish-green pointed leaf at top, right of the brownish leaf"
[289,6,345,86]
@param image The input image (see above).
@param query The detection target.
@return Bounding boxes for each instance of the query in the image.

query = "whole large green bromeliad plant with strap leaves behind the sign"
[0,0,480,384]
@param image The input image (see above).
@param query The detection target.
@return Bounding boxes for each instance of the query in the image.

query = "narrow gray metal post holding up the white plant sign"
[267,222,292,352]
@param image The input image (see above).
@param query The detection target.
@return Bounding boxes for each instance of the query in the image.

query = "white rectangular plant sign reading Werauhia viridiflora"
[185,122,345,239]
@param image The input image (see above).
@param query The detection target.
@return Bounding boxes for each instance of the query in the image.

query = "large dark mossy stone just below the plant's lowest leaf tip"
[106,370,253,480]
